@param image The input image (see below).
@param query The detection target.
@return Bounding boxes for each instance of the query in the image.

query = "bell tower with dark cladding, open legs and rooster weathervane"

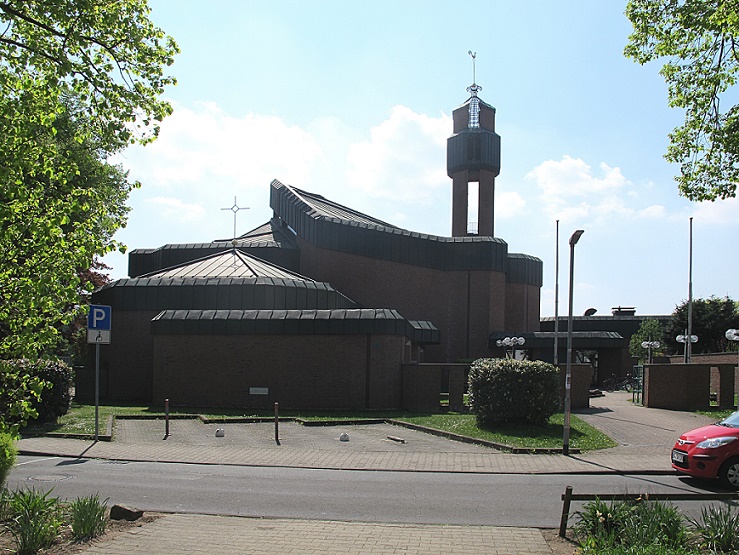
[446,52,500,237]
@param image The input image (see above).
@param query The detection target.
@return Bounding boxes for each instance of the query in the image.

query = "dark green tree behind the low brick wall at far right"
[665,297,739,354]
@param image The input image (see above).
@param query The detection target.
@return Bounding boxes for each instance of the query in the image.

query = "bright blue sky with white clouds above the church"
[104,0,739,317]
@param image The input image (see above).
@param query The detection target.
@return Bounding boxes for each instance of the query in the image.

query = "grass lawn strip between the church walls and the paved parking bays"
[25,403,616,451]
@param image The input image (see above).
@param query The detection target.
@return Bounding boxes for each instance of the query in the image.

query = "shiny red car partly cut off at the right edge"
[672,412,739,489]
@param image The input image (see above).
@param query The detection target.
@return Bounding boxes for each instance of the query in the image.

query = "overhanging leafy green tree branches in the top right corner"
[624,0,739,201]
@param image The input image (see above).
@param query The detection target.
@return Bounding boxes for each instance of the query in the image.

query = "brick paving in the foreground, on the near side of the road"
[84,514,551,555]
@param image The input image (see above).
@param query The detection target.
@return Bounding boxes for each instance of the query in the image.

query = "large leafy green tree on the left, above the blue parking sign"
[0,0,177,358]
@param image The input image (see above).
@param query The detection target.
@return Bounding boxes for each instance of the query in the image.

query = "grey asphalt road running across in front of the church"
[8,456,724,528]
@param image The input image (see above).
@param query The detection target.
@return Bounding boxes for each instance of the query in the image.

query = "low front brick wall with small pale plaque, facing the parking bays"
[153,335,404,409]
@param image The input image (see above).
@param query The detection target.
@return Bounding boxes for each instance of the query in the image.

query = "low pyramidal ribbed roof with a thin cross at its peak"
[139,249,313,281]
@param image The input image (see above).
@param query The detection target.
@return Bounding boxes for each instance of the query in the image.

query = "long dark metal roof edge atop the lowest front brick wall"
[152,308,439,344]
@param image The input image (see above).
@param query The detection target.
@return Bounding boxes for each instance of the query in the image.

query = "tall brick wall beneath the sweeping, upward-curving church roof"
[298,237,508,362]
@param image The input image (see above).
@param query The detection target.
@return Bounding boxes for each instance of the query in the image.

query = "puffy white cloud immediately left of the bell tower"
[347,106,452,204]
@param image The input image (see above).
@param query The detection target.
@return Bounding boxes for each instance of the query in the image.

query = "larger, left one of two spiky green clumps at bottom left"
[7,489,62,554]
